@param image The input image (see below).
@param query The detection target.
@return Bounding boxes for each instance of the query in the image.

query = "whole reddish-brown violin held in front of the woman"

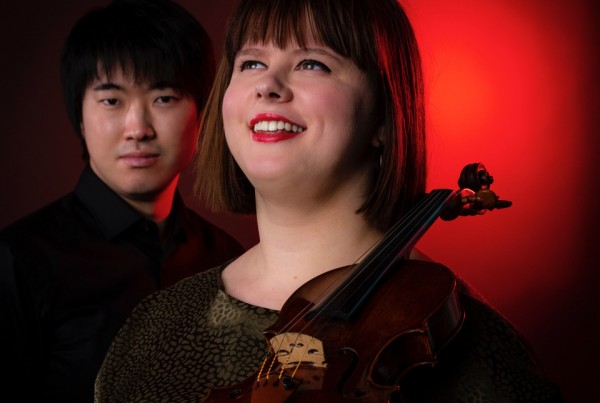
[202,163,512,403]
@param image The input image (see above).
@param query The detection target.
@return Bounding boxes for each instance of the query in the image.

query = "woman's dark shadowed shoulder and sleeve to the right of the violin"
[403,263,563,402]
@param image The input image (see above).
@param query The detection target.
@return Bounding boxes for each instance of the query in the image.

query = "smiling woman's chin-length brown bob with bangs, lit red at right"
[196,0,426,234]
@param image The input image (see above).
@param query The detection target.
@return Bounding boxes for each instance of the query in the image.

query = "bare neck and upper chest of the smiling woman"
[223,197,383,309]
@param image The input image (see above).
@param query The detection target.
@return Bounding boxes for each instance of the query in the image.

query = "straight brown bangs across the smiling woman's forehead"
[225,0,377,76]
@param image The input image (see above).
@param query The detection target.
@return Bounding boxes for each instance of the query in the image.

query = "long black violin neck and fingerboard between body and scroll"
[307,189,454,320]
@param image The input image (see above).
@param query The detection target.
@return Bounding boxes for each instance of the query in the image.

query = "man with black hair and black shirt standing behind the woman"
[0,0,242,402]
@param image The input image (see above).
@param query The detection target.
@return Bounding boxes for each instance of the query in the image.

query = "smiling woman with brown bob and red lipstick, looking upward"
[96,0,560,402]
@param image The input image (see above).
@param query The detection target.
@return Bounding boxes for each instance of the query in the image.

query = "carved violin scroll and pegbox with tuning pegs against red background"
[440,163,512,221]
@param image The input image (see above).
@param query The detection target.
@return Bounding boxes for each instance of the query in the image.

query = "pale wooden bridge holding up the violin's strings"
[270,333,327,368]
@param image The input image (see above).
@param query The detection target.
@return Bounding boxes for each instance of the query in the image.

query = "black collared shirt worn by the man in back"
[0,167,243,402]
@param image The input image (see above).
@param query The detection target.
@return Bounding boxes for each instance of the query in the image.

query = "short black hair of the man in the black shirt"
[61,0,215,160]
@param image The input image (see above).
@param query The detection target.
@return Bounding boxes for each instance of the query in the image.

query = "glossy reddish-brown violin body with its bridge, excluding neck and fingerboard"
[204,260,464,402]
